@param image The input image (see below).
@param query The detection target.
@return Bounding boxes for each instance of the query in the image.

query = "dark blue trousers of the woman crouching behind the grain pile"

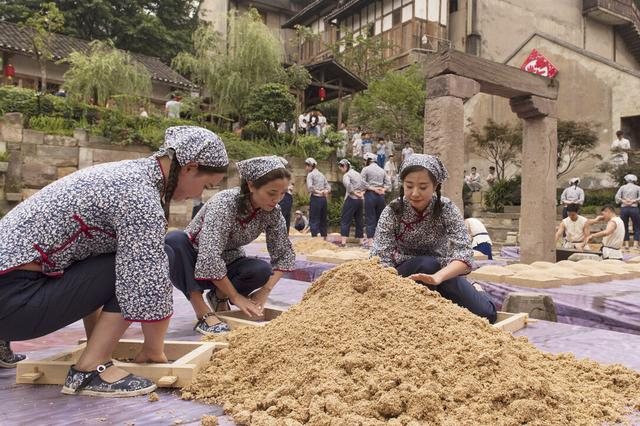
[396,256,497,324]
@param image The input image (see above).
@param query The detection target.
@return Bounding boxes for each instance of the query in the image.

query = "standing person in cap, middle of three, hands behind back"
[338,158,366,247]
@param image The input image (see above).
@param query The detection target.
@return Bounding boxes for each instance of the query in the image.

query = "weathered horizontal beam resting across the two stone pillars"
[420,50,558,99]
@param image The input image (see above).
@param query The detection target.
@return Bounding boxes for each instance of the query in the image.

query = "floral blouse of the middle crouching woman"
[185,188,296,281]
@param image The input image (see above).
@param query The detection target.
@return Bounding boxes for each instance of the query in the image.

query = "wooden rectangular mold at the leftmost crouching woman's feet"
[16,339,227,388]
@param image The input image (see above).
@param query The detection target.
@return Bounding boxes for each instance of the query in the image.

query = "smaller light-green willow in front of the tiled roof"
[64,40,151,105]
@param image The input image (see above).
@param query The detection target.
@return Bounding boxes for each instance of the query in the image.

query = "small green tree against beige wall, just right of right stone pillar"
[558,120,602,177]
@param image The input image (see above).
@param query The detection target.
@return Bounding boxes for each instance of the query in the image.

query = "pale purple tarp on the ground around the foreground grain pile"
[0,253,640,426]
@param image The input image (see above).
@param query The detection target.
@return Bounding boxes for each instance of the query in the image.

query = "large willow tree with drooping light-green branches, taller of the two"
[172,9,286,123]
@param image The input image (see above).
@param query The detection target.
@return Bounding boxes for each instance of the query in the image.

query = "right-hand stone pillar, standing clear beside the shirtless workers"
[510,96,558,263]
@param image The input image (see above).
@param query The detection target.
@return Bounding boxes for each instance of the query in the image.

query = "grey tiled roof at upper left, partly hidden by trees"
[0,21,194,88]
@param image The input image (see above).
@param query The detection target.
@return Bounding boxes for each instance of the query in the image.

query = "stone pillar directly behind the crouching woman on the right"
[424,74,480,211]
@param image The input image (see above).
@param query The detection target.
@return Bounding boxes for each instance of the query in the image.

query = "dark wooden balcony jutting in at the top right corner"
[582,0,640,62]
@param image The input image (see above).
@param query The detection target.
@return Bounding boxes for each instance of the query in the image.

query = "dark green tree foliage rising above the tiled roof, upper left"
[0,0,201,63]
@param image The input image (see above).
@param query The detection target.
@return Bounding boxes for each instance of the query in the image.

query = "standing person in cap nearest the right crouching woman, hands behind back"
[360,153,391,246]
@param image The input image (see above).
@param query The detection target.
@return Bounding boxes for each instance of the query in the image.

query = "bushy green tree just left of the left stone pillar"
[350,65,426,144]
